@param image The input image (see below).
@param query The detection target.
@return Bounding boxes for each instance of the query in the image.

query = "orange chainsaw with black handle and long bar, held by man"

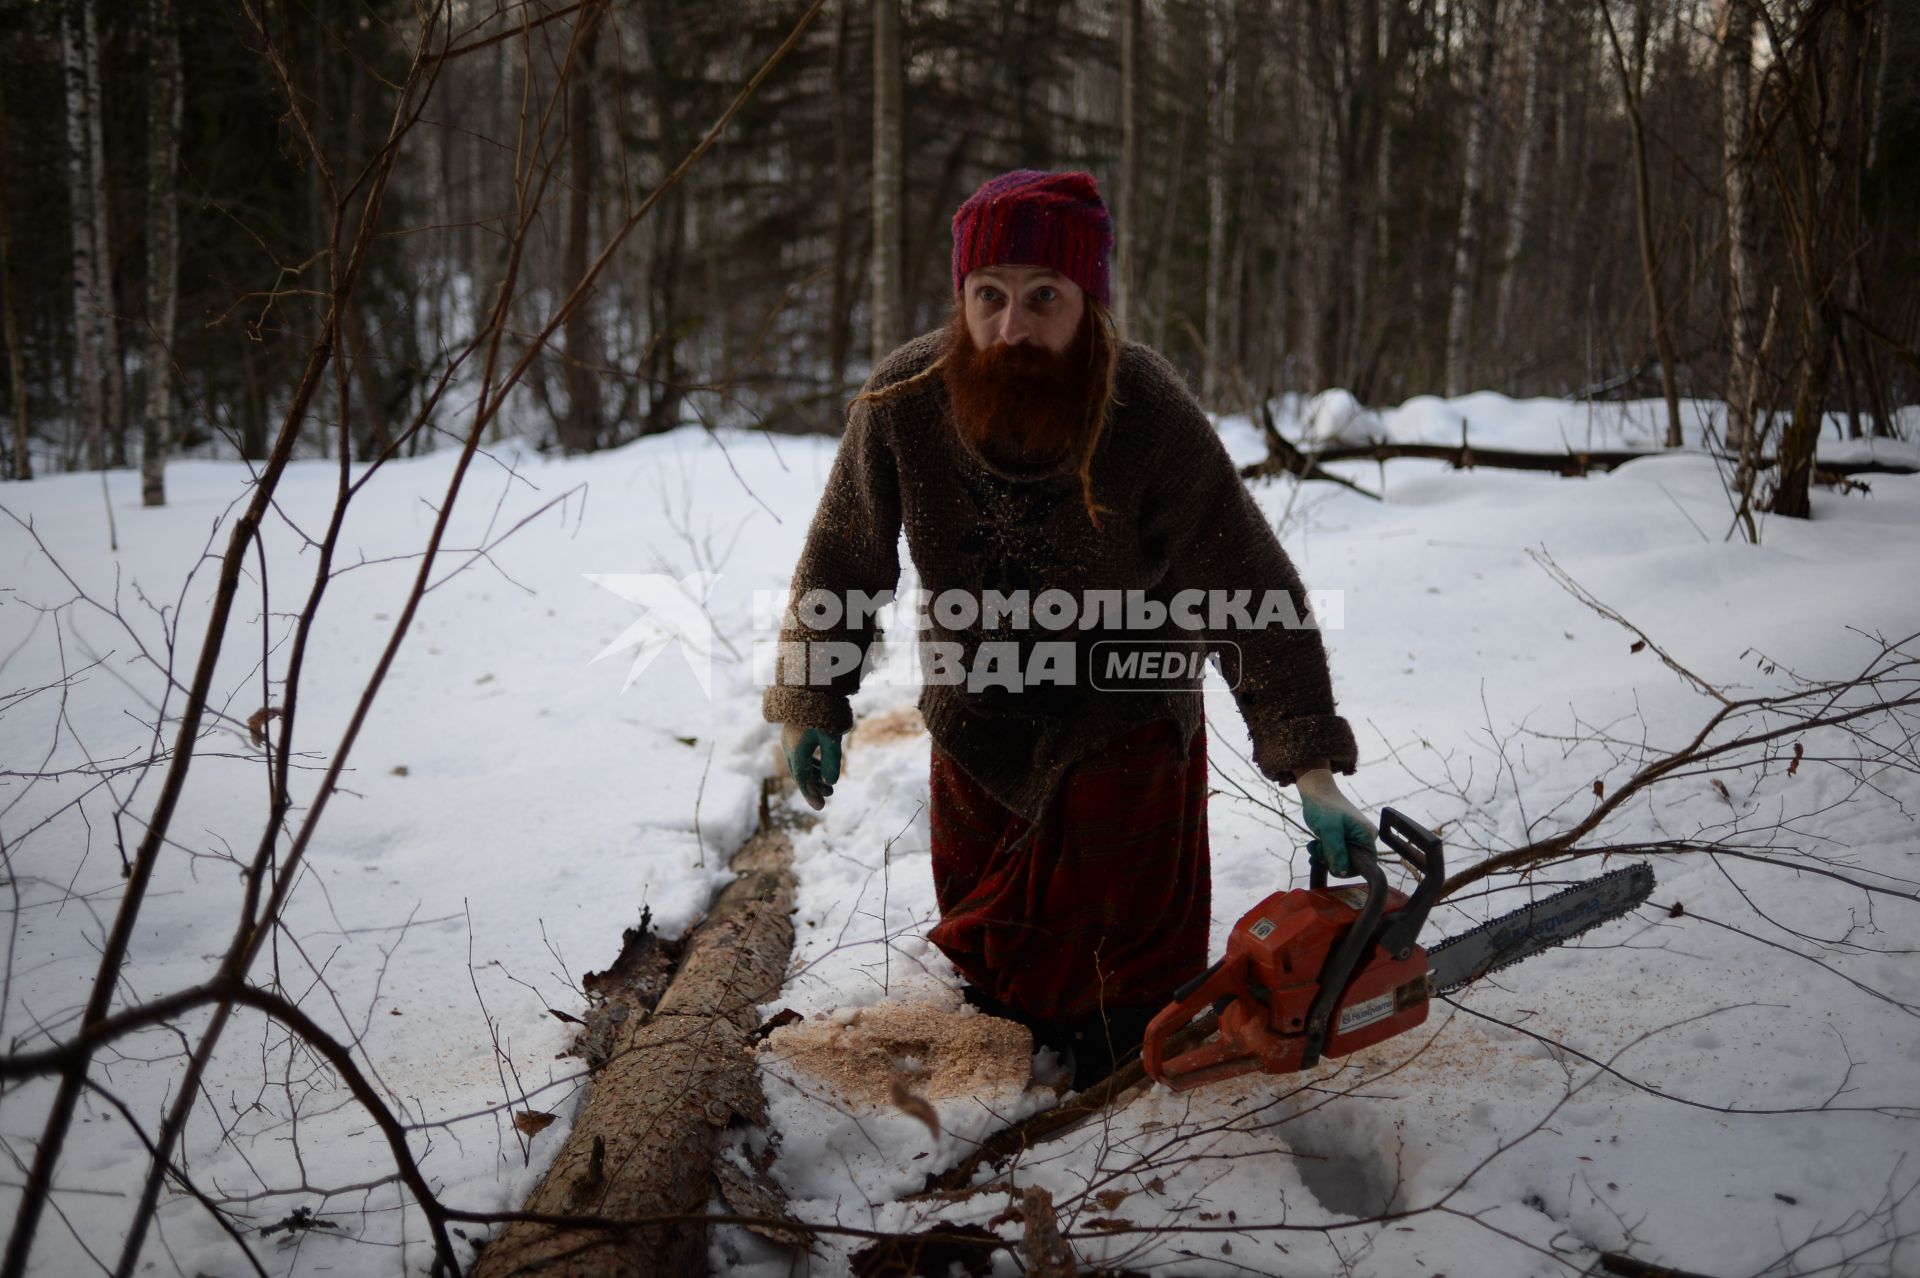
[1140,808,1653,1092]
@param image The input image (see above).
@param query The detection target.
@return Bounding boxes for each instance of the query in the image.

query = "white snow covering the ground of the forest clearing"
[0,393,1920,1278]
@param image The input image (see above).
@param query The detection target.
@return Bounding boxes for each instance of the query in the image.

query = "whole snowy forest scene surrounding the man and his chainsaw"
[0,0,1920,1278]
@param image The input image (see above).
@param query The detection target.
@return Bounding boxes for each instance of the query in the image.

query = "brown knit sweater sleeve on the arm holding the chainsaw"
[1142,358,1359,785]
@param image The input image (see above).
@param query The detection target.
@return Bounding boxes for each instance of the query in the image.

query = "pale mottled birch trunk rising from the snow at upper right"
[1720,0,1761,451]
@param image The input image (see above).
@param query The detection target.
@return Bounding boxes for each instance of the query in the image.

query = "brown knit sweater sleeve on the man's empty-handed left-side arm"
[760,378,900,733]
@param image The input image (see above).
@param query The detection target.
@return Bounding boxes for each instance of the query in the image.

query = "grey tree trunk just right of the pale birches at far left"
[140,0,180,507]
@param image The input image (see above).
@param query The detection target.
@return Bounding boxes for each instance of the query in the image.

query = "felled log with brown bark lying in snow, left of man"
[472,829,795,1278]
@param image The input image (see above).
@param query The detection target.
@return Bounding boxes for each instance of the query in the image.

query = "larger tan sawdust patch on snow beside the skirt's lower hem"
[768,1004,1033,1105]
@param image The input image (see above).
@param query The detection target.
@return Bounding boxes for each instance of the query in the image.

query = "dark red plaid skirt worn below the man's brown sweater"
[927,720,1210,1021]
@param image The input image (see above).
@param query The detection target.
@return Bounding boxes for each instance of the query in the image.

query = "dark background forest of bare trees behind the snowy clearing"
[0,0,1920,487]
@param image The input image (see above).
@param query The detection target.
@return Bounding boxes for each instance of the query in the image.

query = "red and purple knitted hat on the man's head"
[954,169,1114,305]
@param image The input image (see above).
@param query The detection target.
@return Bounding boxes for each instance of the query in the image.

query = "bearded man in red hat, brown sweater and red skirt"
[762,169,1373,1088]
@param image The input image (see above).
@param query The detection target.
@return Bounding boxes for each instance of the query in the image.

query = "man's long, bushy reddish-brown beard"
[941,309,1098,468]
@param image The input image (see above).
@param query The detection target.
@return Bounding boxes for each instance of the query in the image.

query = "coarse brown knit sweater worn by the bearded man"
[762,328,1356,821]
